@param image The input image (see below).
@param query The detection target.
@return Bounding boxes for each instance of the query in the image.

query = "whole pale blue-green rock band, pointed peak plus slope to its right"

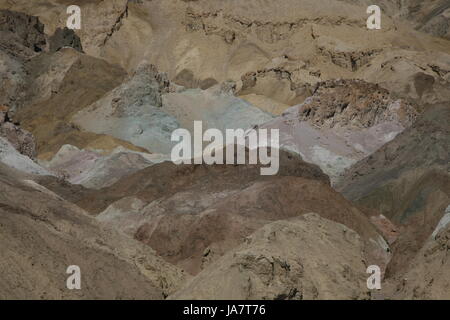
[73,63,272,154]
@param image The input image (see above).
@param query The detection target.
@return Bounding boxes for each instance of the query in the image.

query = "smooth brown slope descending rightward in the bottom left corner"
[0,165,184,299]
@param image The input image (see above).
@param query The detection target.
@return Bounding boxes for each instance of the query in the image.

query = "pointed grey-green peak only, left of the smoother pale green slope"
[73,63,179,153]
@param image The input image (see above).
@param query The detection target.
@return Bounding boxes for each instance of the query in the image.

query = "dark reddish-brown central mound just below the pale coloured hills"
[72,152,388,274]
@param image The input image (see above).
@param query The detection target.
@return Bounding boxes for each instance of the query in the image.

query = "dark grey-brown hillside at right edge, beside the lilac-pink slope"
[337,105,450,288]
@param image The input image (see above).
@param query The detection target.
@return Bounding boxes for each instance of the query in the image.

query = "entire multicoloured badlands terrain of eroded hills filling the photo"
[0,0,450,300]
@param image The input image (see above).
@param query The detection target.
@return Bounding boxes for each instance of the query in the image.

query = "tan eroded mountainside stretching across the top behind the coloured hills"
[2,0,450,106]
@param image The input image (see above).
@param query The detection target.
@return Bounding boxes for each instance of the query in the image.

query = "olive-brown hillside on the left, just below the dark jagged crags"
[13,48,145,160]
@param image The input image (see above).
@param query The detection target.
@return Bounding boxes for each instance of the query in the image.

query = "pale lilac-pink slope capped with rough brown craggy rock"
[261,80,417,182]
